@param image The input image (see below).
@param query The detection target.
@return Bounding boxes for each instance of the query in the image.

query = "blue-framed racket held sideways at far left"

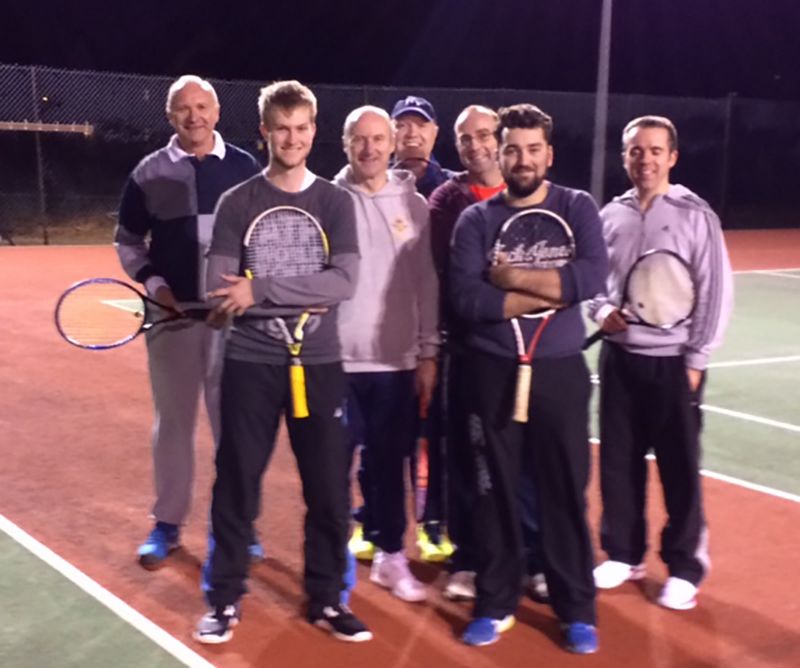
[55,278,310,350]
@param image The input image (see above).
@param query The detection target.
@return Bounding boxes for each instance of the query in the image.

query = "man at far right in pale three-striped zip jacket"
[589,116,733,610]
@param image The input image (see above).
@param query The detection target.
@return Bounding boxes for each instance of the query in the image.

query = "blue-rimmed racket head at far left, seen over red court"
[55,278,147,350]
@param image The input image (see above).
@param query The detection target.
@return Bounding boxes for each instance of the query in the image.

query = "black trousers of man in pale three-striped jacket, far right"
[599,342,709,585]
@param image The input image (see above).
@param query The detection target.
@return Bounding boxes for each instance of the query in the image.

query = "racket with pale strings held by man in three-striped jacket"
[583,249,697,350]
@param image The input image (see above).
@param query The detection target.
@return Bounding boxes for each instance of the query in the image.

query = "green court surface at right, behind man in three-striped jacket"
[587,271,800,495]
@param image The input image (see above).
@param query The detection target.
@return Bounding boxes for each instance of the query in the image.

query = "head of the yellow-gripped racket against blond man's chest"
[242,206,330,278]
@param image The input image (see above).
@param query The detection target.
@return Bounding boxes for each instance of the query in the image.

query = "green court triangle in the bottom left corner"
[0,532,183,668]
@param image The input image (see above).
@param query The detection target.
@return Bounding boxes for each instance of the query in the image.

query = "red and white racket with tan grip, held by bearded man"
[492,209,575,422]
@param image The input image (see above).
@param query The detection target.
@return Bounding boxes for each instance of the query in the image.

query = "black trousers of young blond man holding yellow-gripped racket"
[206,359,350,607]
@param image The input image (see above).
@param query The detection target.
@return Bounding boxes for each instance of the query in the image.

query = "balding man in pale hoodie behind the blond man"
[334,106,439,602]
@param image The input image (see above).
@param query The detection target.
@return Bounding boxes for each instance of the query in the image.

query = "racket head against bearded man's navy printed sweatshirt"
[491,209,575,318]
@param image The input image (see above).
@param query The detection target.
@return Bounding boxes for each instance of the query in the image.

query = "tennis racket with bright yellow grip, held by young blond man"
[243,206,330,418]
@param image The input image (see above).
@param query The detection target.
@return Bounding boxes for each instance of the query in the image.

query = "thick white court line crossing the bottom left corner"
[0,515,214,668]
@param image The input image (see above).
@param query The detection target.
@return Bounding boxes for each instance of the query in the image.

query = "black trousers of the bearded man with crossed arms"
[467,351,595,624]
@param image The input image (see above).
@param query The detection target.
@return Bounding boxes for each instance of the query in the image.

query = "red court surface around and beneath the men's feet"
[0,230,800,668]
